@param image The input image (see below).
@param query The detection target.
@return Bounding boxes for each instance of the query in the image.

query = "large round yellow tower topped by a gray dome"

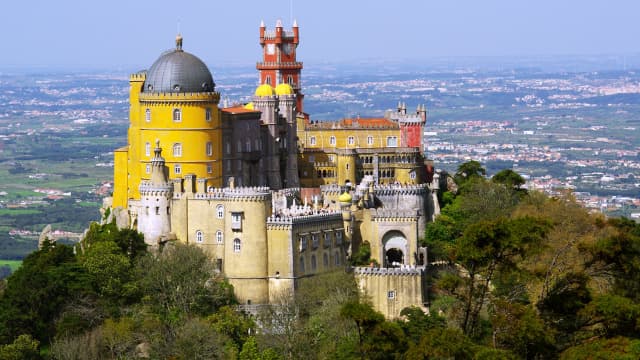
[114,35,222,208]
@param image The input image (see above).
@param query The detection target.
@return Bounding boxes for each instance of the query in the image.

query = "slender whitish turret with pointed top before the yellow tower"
[138,142,173,246]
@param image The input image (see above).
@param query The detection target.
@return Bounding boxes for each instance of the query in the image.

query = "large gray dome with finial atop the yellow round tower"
[142,43,215,93]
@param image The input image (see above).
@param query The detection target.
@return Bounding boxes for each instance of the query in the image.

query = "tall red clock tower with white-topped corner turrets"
[256,20,304,113]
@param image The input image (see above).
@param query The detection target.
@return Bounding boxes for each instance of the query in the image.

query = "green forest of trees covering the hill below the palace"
[0,161,640,360]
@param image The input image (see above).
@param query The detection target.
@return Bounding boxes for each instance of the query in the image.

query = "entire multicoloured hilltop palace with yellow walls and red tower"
[110,21,439,317]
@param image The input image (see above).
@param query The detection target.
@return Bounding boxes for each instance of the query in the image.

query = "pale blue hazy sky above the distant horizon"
[0,0,640,69]
